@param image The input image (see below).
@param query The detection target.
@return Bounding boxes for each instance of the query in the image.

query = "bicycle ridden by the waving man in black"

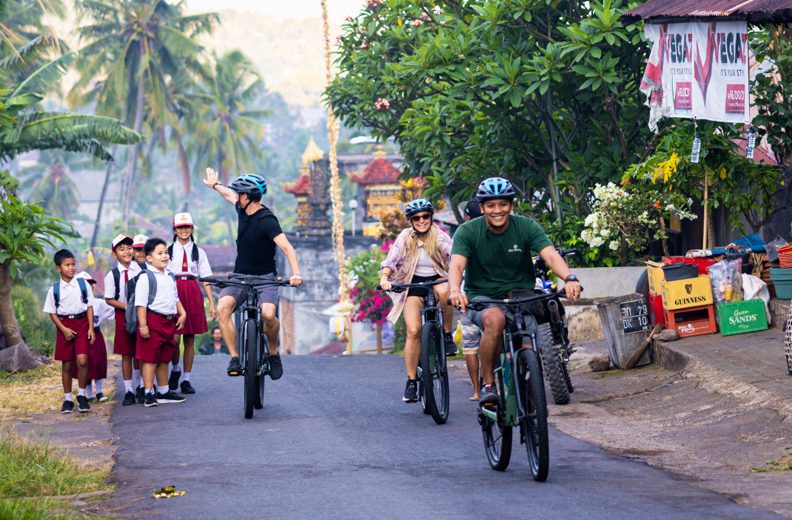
[198,277,291,419]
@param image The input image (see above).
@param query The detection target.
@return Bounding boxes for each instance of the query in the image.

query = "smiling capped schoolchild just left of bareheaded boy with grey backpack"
[105,235,143,406]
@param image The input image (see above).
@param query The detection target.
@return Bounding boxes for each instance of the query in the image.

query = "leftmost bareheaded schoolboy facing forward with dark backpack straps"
[44,249,96,413]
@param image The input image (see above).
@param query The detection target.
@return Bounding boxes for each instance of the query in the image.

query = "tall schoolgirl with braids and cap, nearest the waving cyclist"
[168,213,217,394]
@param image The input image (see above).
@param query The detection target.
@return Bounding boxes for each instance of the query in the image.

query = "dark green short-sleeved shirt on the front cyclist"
[451,215,553,299]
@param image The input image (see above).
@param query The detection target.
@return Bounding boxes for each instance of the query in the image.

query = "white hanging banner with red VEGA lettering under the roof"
[641,22,750,132]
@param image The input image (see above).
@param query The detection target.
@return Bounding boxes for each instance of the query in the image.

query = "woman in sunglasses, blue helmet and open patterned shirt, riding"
[380,199,457,403]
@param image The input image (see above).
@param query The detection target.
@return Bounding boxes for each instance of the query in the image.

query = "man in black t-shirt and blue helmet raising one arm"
[204,168,302,379]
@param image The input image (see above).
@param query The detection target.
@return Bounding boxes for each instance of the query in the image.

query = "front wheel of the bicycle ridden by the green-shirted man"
[516,349,550,482]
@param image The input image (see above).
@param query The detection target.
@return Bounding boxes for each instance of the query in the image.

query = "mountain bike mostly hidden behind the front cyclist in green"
[533,248,577,404]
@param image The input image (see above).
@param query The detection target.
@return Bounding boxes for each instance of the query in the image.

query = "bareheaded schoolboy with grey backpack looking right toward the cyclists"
[135,238,187,407]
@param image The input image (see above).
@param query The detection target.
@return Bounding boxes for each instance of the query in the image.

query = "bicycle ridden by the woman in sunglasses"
[377,280,449,424]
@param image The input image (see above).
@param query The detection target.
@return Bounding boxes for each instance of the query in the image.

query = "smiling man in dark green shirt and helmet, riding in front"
[448,177,580,404]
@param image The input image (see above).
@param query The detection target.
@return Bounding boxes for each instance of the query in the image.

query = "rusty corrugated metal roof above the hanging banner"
[622,0,792,23]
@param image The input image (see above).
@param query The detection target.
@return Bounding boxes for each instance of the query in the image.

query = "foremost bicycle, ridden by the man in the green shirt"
[460,292,564,482]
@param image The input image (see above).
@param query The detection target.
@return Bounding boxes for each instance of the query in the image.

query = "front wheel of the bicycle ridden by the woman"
[421,321,449,424]
